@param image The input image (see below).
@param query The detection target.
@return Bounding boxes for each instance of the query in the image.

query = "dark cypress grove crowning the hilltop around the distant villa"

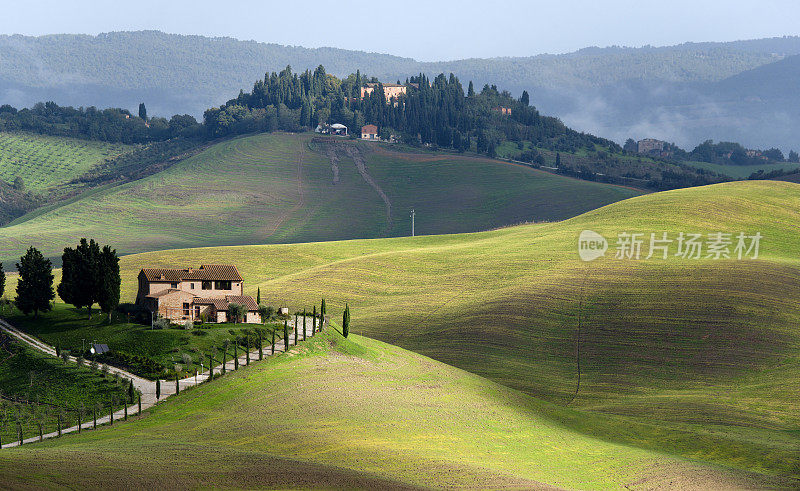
[204,66,619,156]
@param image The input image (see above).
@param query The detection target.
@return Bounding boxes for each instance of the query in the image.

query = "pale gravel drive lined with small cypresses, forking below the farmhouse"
[0,317,324,448]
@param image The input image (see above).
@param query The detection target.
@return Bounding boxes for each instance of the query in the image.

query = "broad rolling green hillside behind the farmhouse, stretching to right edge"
[98,181,800,476]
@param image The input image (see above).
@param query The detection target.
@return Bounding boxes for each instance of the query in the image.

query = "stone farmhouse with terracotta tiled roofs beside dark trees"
[136,264,261,324]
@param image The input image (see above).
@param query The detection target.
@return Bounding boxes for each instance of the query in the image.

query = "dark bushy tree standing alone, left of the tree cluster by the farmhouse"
[16,247,56,317]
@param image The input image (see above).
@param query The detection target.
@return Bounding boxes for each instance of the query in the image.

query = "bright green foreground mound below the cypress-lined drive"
[0,329,787,489]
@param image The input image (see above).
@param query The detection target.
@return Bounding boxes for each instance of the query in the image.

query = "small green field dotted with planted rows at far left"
[0,132,133,191]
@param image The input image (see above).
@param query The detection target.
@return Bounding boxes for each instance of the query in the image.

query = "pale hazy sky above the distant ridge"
[0,0,800,61]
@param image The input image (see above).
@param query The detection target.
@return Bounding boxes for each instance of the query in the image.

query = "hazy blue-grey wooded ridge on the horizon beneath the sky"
[0,31,800,149]
